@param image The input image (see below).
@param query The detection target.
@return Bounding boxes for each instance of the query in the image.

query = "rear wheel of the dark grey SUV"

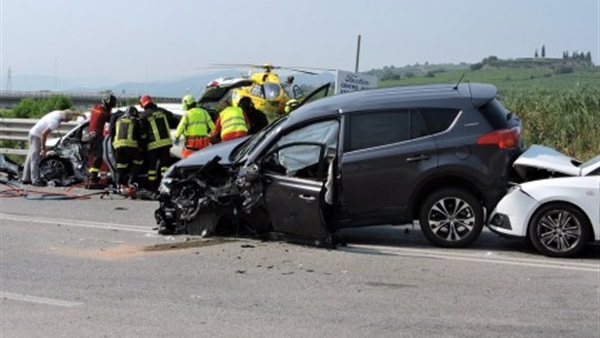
[419,188,483,248]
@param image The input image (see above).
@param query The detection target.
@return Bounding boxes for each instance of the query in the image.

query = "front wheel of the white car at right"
[527,203,591,257]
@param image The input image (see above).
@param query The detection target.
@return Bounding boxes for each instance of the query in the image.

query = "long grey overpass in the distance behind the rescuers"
[0,90,181,110]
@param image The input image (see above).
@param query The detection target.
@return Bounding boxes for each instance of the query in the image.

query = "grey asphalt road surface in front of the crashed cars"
[0,186,600,338]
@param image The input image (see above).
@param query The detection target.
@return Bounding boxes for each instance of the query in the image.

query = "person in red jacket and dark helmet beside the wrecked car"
[88,95,117,184]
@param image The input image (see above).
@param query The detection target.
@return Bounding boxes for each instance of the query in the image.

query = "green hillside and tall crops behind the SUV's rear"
[379,61,600,160]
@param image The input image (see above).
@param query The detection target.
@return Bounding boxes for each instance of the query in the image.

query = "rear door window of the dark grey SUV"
[347,109,411,151]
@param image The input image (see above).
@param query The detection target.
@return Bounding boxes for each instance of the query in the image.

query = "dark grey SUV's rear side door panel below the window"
[339,137,437,226]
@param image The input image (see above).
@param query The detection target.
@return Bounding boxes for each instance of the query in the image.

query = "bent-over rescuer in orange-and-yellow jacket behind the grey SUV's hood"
[209,99,250,143]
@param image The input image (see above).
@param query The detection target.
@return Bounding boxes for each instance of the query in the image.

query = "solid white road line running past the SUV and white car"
[346,245,600,273]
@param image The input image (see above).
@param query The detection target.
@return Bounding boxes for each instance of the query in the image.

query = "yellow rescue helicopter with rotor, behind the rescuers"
[207,63,330,116]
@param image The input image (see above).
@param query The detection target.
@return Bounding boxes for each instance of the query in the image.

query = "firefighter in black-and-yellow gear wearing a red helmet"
[140,95,179,192]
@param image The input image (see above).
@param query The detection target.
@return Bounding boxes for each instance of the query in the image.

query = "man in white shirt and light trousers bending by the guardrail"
[21,109,80,186]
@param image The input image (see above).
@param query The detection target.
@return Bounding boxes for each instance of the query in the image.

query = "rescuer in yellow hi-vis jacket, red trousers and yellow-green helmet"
[174,95,215,158]
